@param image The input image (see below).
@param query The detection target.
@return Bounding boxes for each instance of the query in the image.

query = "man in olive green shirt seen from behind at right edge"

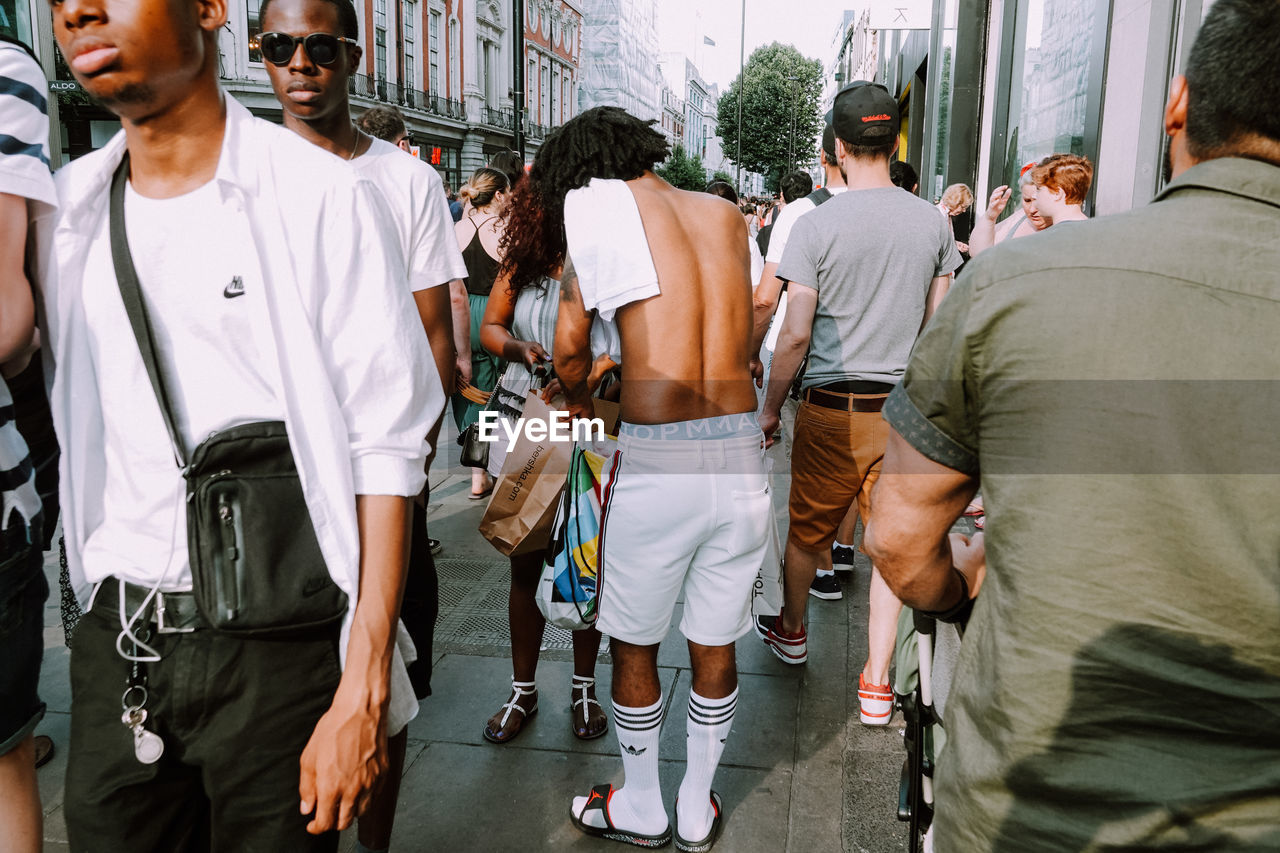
[867,0,1280,853]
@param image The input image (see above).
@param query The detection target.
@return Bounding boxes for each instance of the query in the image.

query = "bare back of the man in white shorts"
[617,173,756,424]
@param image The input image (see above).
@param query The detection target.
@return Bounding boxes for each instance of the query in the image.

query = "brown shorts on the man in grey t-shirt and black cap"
[788,394,888,551]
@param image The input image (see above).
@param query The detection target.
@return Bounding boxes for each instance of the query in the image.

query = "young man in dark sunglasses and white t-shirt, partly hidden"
[259,0,470,853]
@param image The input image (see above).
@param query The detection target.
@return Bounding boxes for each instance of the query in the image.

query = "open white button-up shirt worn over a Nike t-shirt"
[37,97,444,712]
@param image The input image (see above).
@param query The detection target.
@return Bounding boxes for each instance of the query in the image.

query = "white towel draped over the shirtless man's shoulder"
[564,178,660,323]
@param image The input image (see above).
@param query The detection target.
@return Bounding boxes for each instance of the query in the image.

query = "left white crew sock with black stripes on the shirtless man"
[573,697,667,835]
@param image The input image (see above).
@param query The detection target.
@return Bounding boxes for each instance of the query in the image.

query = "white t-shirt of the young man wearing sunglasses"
[351,140,467,292]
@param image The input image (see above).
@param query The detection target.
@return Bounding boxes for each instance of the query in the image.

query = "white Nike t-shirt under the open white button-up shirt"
[84,182,284,592]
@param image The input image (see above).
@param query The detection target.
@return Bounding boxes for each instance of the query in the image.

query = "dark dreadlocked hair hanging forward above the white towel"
[498,106,671,293]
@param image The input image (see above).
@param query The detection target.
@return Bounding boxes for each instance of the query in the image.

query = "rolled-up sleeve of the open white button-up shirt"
[320,179,444,496]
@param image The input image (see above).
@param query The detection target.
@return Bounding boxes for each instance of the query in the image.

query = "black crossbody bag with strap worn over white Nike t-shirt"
[110,155,347,635]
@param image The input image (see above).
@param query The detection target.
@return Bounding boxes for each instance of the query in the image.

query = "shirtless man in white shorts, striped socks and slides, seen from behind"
[496,106,769,850]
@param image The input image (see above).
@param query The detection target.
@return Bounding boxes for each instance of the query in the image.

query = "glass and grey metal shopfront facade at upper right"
[833,0,1212,215]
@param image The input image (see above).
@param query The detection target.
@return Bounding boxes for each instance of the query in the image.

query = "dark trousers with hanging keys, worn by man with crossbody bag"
[65,589,342,853]
